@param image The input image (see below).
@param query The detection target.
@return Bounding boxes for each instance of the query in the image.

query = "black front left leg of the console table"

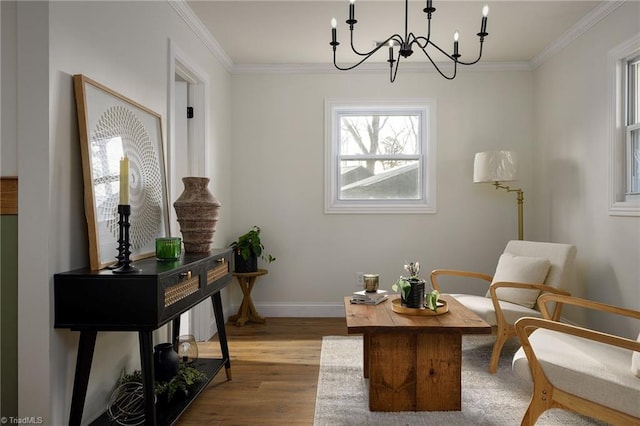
[69,331,98,426]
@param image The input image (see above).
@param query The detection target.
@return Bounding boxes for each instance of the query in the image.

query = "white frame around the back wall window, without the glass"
[324,99,436,214]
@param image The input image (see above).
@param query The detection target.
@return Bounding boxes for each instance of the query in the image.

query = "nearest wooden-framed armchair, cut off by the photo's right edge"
[512,294,640,426]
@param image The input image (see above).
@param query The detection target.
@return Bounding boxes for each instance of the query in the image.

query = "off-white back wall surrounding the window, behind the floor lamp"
[231,69,536,316]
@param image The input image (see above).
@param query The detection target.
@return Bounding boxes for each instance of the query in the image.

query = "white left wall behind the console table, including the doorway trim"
[3,2,231,425]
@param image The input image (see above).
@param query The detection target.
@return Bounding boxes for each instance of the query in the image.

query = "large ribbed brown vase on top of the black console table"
[173,177,221,253]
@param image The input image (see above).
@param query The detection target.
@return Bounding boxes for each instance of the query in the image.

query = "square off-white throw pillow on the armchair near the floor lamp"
[487,253,551,308]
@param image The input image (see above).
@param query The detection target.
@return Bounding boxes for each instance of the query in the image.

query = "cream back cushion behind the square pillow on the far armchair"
[504,240,577,290]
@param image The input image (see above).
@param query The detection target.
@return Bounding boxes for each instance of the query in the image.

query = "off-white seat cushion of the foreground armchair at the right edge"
[512,329,640,417]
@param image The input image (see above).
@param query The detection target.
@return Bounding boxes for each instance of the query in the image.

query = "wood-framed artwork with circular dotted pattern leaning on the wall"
[73,74,169,270]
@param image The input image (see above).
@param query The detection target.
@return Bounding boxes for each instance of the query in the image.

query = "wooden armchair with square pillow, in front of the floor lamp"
[431,240,576,373]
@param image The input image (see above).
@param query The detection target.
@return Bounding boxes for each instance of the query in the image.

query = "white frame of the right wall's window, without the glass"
[607,34,640,216]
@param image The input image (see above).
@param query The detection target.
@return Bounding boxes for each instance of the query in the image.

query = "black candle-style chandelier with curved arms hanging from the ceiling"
[329,0,489,83]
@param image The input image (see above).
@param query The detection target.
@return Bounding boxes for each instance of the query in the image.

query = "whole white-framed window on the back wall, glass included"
[325,100,435,213]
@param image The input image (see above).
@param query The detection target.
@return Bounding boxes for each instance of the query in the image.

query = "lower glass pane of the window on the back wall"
[340,160,421,200]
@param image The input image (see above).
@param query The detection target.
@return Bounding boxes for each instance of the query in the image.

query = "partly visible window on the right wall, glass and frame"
[609,35,640,216]
